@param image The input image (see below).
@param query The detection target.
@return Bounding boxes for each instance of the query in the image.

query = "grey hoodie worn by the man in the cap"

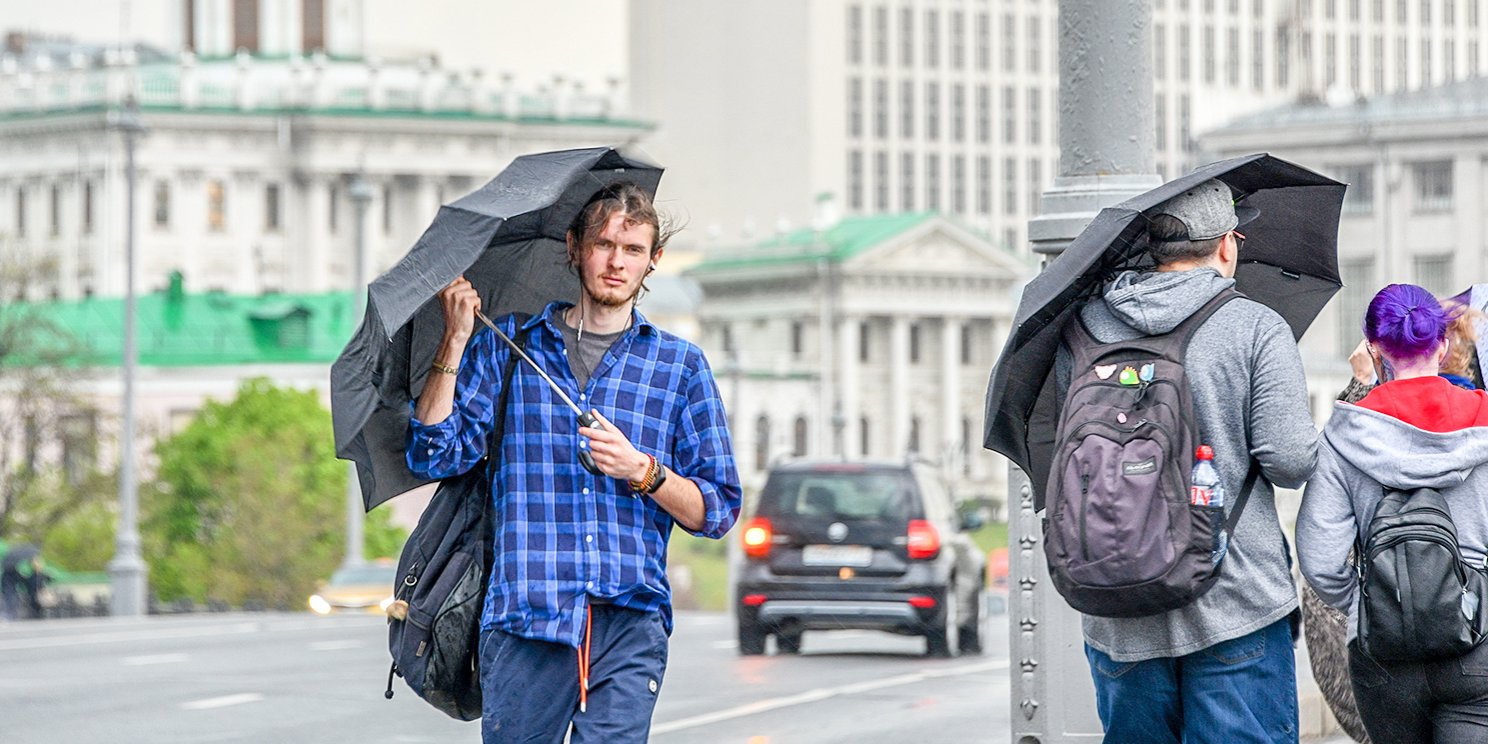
[1055,268,1317,661]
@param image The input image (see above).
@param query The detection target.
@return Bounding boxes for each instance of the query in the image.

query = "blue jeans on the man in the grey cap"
[1085,619,1298,744]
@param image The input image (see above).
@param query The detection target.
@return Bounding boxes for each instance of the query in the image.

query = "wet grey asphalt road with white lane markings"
[0,613,1009,744]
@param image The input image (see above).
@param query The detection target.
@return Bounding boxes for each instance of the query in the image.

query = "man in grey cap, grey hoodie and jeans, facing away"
[1056,180,1317,744]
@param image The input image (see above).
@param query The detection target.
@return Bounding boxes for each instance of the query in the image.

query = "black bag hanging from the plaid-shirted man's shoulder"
[384,322,527,720]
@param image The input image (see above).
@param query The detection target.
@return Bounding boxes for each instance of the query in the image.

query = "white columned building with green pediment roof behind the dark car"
[687,213,1034,501]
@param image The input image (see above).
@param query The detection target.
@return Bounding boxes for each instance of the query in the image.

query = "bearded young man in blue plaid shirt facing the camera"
[408,185,740,744]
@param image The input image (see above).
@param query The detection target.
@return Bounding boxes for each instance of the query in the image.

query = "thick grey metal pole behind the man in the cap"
[1007,0,1162,744]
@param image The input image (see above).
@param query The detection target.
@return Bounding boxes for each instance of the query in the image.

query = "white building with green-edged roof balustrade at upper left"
[0,37,649,298]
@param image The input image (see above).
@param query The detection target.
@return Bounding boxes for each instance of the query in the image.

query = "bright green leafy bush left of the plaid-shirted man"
[141,379,403,607]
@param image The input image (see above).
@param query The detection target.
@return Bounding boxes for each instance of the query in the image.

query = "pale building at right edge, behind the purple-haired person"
[1202,77,1488,414]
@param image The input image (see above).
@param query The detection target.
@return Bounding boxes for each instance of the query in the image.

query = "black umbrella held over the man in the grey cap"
[984,153,1347,503]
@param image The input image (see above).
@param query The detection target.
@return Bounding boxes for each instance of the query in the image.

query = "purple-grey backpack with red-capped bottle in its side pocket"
[1043,289,1259,618]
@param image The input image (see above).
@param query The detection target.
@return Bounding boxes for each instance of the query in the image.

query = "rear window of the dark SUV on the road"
[759,470,918,522]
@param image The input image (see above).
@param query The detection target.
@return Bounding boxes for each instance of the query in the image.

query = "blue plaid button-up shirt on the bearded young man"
[408,302,740,647]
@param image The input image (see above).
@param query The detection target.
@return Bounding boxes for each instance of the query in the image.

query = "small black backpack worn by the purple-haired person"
[1354,488,1488,661]
